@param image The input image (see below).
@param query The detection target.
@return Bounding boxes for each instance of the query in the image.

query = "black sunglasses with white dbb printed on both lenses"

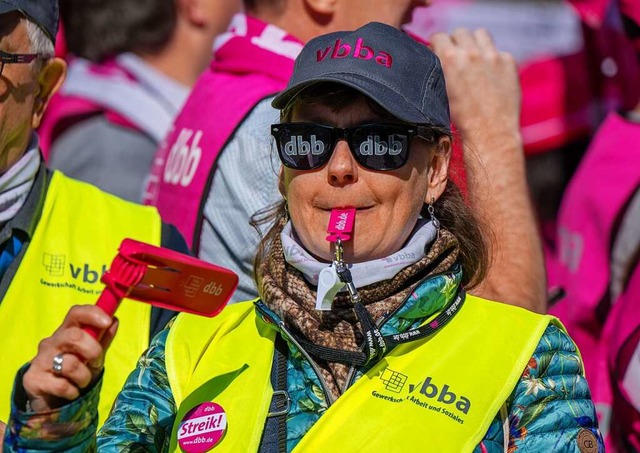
[271,123,433,171]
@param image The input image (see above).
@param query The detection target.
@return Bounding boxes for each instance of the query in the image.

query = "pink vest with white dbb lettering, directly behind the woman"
[144,15,302,247]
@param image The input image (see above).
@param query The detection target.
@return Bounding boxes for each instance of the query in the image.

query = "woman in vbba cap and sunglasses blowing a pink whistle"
[7,23,602,452]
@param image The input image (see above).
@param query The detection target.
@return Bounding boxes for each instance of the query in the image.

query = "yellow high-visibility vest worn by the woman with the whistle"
[166,296,560,453]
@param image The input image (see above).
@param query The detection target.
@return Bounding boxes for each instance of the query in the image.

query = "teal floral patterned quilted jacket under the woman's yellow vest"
[4,273,604,453]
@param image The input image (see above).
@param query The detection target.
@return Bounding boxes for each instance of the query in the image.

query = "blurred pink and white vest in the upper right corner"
[408,0,640,155]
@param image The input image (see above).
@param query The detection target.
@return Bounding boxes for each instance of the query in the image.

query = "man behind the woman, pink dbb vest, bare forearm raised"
[145,0,545,311]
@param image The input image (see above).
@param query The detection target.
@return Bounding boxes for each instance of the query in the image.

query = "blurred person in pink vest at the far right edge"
[547,0,640,452]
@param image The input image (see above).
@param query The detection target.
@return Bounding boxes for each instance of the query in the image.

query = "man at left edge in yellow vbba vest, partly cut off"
[0,0,186,434]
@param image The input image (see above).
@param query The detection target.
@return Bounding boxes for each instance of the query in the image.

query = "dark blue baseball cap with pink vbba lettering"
[272,22,451,130]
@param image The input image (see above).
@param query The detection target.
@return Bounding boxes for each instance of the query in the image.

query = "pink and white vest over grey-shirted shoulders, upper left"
[38,56,179,159]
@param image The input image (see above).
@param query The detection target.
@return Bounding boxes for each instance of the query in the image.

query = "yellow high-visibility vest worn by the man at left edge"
[0,172,162,423]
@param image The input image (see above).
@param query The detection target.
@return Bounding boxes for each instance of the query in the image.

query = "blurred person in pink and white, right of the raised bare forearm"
[407,0,640,251]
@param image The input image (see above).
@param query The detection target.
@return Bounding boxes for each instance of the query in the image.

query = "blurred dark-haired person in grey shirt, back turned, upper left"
[40,0,241,202]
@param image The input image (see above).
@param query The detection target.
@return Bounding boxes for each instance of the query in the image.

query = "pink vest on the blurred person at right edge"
[547,112,640,448]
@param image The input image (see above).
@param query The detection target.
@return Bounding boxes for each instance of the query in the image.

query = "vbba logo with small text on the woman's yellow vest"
[372,368,471,424]
